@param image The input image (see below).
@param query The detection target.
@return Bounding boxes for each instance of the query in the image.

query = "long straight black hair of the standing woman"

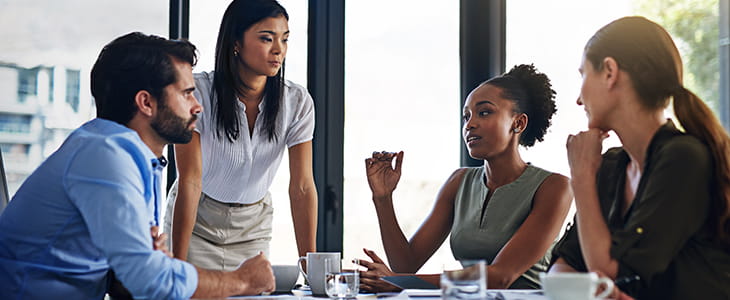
[211,0,289,142]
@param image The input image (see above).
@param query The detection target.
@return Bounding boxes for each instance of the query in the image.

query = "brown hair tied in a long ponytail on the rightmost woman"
[585,17,730,248]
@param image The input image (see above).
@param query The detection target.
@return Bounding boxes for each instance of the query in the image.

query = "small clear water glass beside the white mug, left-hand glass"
[324,258,360,299]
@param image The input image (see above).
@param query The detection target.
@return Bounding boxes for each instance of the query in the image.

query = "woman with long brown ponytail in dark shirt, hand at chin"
[551,17,730,299]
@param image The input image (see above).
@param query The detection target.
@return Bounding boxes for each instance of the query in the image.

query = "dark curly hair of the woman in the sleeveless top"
[483,64,557,147]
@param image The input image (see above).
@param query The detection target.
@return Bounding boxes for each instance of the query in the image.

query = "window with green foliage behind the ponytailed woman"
[506,0,719,175]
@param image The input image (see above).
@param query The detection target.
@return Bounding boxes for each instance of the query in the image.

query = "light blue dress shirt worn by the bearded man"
[0,119,198,300]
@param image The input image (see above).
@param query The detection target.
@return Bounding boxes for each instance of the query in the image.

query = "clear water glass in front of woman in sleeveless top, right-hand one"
[441,260,487,300]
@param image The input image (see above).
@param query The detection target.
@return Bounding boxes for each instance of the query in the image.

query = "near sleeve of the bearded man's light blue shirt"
[64,140,198,299]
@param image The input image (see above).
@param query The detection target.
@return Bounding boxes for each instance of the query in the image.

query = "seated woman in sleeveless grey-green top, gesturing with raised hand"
[360,65,572,291]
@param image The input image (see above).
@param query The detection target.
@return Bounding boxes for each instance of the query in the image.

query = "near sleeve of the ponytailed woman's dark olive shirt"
[610,136,712,283]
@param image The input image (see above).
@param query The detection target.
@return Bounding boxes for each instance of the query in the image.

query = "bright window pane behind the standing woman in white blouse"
[190,0,308,264]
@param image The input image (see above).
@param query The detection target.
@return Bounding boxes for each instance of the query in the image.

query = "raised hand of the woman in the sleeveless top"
[365,151,403,200]
